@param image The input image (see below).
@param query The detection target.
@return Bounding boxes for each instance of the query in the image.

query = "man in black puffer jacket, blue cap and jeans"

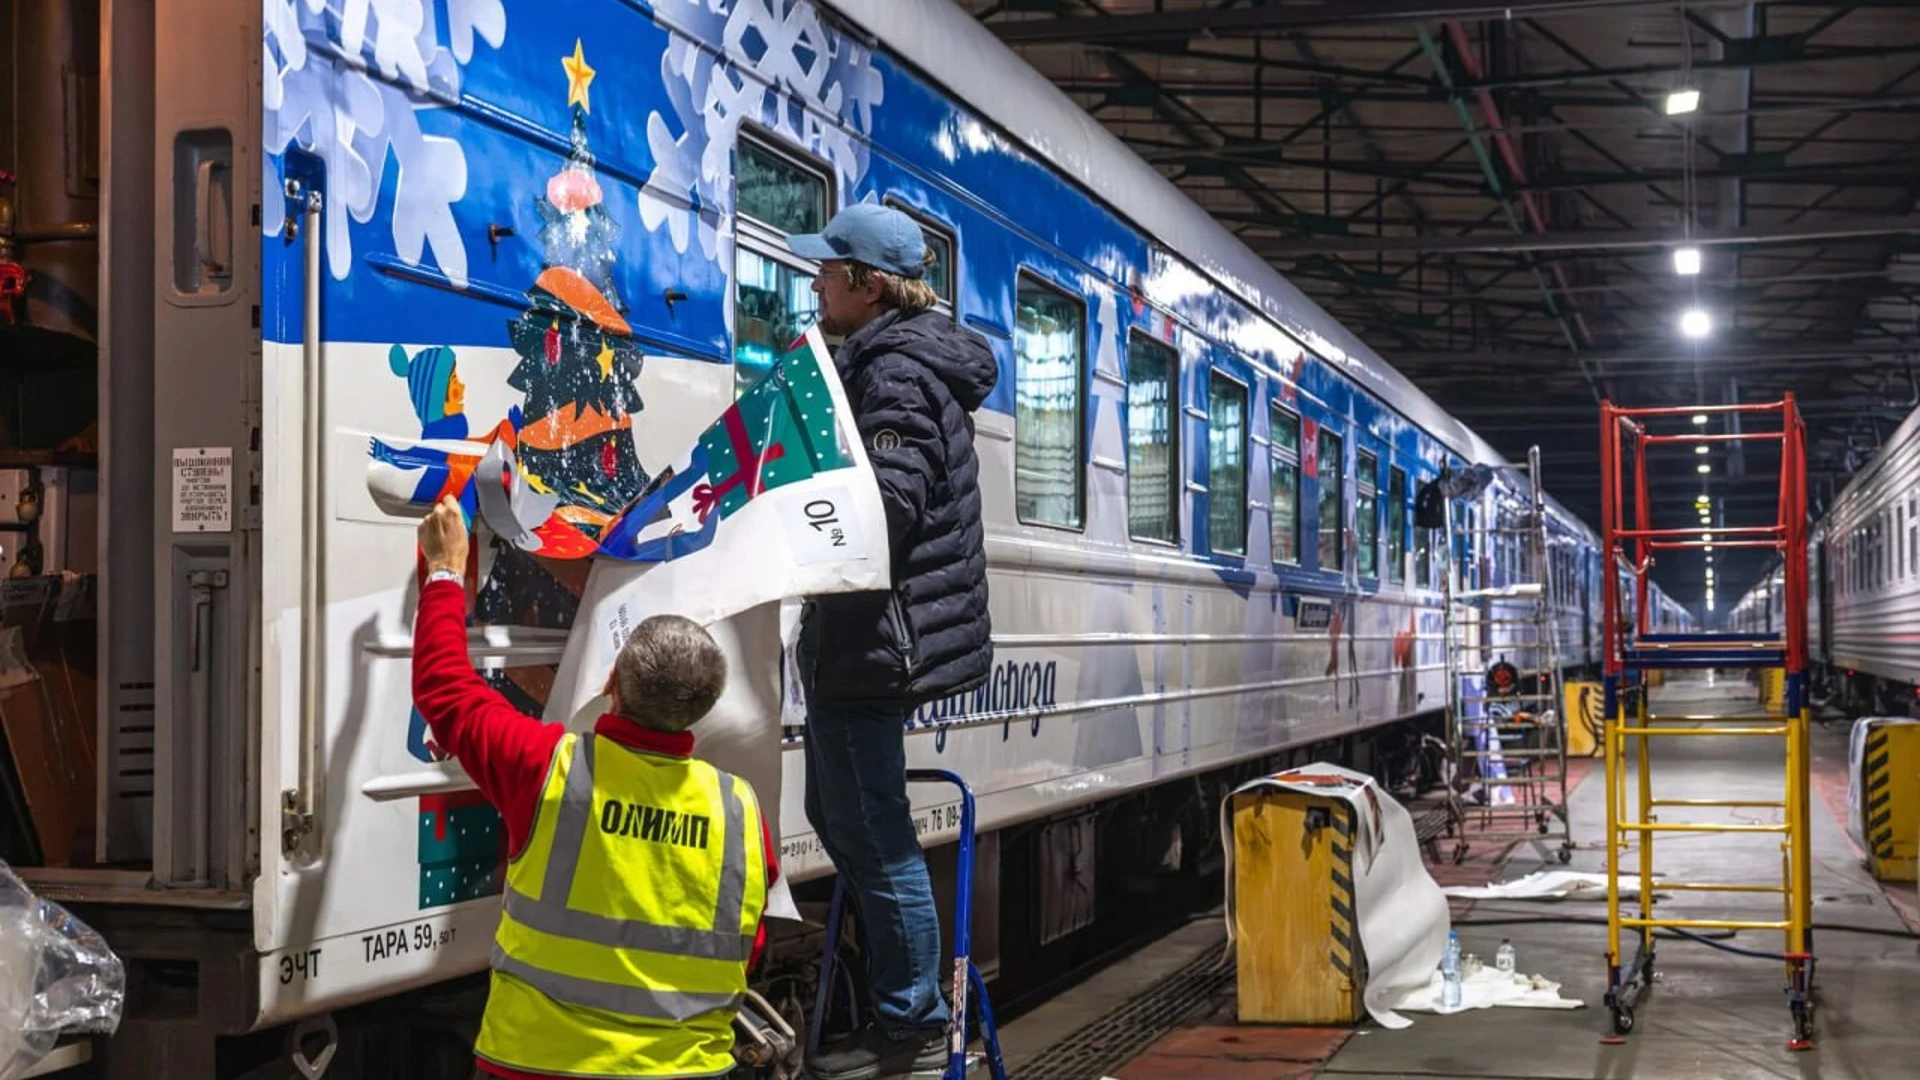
[789,204,998,1080]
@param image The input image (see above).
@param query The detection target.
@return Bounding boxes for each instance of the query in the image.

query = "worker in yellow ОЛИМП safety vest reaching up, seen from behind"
[413,500,778,1080]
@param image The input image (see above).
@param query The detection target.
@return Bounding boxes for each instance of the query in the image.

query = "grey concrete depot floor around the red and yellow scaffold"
[1321,684,1920,1080]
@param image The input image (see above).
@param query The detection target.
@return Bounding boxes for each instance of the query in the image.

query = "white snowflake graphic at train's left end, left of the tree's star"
[261,0,507,286]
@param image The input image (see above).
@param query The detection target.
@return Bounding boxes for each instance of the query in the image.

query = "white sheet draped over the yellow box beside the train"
[1219,763,1452,1028]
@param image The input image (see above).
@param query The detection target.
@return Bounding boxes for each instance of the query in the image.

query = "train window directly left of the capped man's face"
[733,136,829,396]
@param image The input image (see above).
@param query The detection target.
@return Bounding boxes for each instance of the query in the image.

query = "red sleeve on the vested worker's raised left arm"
[413,580,566,855]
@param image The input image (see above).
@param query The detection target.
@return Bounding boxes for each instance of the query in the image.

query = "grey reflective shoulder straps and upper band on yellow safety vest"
[507,736,753,957]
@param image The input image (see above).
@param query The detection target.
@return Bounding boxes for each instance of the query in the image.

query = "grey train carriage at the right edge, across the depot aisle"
[1728,397,1920,715]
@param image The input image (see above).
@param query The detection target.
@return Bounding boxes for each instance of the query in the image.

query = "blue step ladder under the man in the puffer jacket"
[806,769,1006,1080]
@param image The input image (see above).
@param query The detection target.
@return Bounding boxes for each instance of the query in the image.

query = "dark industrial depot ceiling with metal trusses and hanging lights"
[964,0,1920,613]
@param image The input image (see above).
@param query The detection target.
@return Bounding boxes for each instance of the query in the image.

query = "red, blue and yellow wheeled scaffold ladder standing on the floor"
[1599,394,1814,1049]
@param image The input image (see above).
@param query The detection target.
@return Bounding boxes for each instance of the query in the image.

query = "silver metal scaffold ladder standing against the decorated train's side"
[1446,446,1572,863]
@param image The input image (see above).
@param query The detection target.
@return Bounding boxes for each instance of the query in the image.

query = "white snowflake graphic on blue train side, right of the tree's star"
[639,0,885,328]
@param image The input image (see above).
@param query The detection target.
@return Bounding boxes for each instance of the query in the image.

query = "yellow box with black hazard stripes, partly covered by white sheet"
[1231,790,1367,1024]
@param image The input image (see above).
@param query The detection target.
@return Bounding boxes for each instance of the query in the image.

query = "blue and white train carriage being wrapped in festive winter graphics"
[18,0,1684,1076]
